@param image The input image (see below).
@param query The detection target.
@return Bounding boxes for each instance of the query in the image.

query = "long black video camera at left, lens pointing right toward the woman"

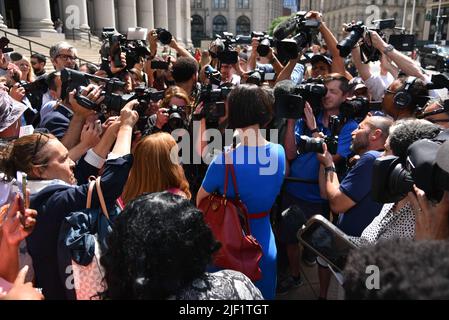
[61,69,164,116]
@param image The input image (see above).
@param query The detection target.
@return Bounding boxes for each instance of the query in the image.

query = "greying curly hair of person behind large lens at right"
[389,119,441,163]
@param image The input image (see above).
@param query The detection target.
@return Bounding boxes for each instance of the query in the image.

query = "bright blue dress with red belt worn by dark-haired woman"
[202,143,286,300]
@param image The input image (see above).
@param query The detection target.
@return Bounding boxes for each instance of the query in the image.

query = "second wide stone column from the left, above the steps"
[62,0,90,31]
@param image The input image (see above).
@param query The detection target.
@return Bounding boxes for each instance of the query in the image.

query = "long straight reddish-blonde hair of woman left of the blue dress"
[122,132,192,204]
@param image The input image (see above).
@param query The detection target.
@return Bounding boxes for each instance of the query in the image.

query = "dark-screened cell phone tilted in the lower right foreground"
[298,215,357,272]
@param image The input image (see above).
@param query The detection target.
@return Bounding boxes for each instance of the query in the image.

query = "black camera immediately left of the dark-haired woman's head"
[196,85,233,123]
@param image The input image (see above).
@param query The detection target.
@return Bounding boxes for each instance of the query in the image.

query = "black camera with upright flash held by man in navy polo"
[298,116,341,155]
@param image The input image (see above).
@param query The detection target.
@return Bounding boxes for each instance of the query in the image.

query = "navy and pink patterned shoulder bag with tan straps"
[57,177,119,300]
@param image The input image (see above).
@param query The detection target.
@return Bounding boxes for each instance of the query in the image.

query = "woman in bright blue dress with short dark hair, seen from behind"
[197,85,285,300]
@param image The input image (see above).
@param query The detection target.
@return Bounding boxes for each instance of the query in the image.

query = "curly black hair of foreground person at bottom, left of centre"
[101,192,220,300]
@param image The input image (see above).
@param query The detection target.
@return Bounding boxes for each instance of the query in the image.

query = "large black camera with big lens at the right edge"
[372,131,449,203]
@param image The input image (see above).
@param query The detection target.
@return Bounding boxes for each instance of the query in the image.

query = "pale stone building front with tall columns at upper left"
[0,0,192,44]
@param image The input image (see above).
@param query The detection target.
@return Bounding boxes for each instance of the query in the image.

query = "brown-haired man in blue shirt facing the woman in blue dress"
[282,74,358,290]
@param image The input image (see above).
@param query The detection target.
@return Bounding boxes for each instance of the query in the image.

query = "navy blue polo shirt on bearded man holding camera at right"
[337,151,382,237]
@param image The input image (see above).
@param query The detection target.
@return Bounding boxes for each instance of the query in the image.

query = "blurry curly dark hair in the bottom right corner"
[344,239,449,300]
